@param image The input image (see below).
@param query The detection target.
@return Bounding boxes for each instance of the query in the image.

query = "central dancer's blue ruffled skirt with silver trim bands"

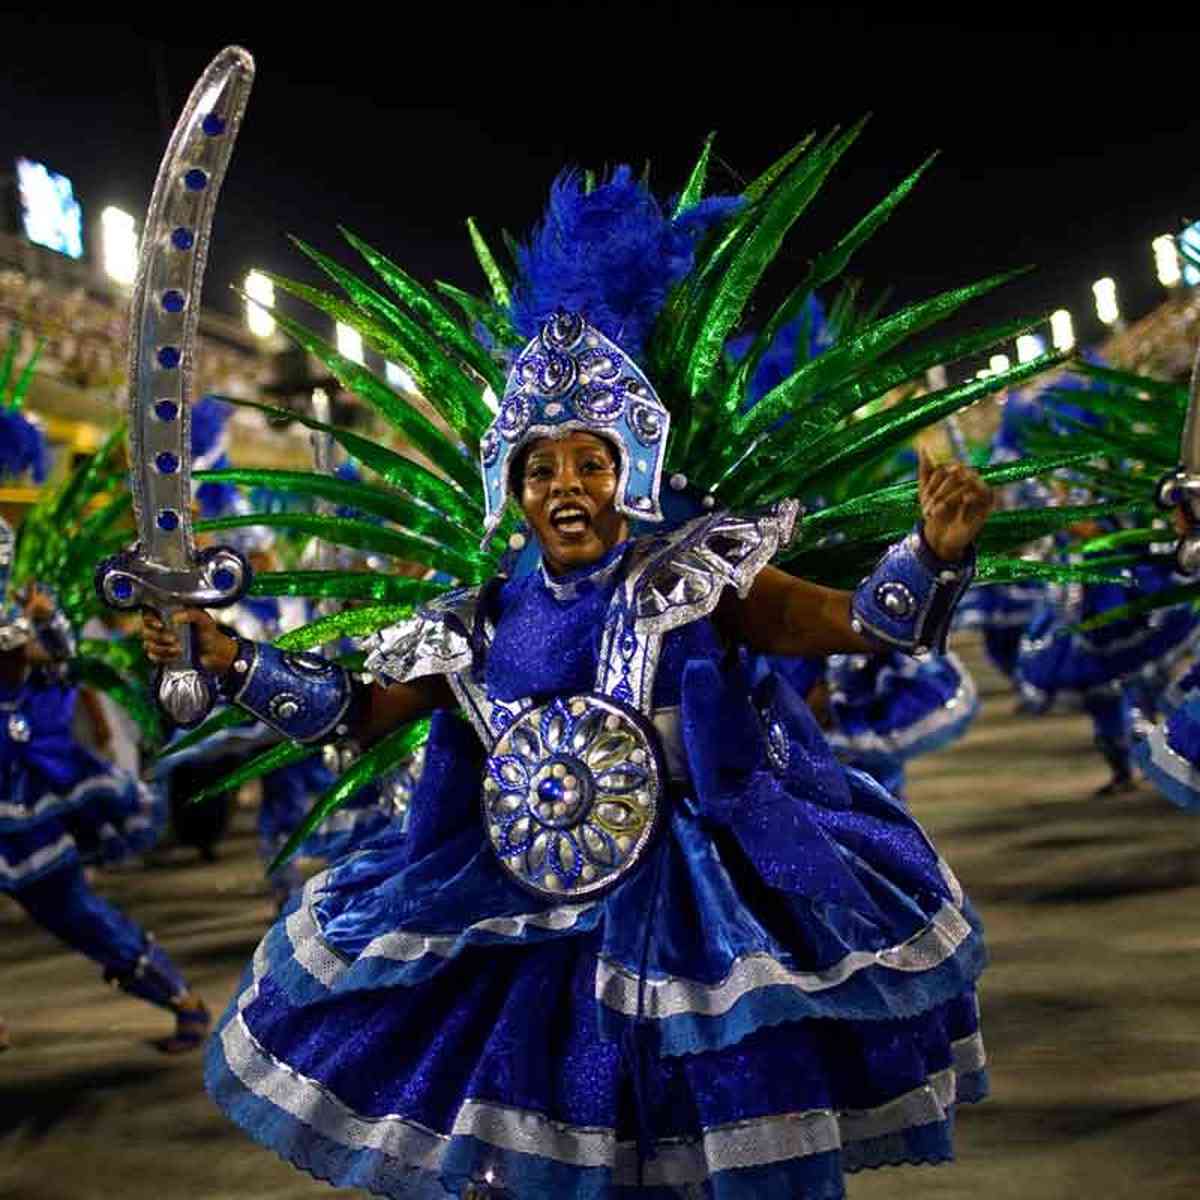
[206,664,986,1200]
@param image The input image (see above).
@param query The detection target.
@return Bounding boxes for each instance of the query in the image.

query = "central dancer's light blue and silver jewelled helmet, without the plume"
[480,311,671,545]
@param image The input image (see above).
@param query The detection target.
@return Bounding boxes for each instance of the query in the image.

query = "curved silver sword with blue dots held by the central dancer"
[96,46,254,727]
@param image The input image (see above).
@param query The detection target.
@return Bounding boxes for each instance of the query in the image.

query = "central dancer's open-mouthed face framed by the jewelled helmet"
[514,431,629,575]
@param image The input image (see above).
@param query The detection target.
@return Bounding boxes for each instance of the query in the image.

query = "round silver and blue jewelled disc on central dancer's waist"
[482,695,664,901]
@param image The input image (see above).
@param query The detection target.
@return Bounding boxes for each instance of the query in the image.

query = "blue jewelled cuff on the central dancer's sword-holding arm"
[222,638,354,742]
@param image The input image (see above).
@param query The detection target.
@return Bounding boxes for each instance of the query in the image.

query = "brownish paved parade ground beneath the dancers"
[0,649,1200,1200]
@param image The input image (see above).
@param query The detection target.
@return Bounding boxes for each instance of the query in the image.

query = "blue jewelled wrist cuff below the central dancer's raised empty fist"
[850,526,976,655]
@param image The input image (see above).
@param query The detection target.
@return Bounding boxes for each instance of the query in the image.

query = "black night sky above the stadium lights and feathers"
[0,11,1200,360]
